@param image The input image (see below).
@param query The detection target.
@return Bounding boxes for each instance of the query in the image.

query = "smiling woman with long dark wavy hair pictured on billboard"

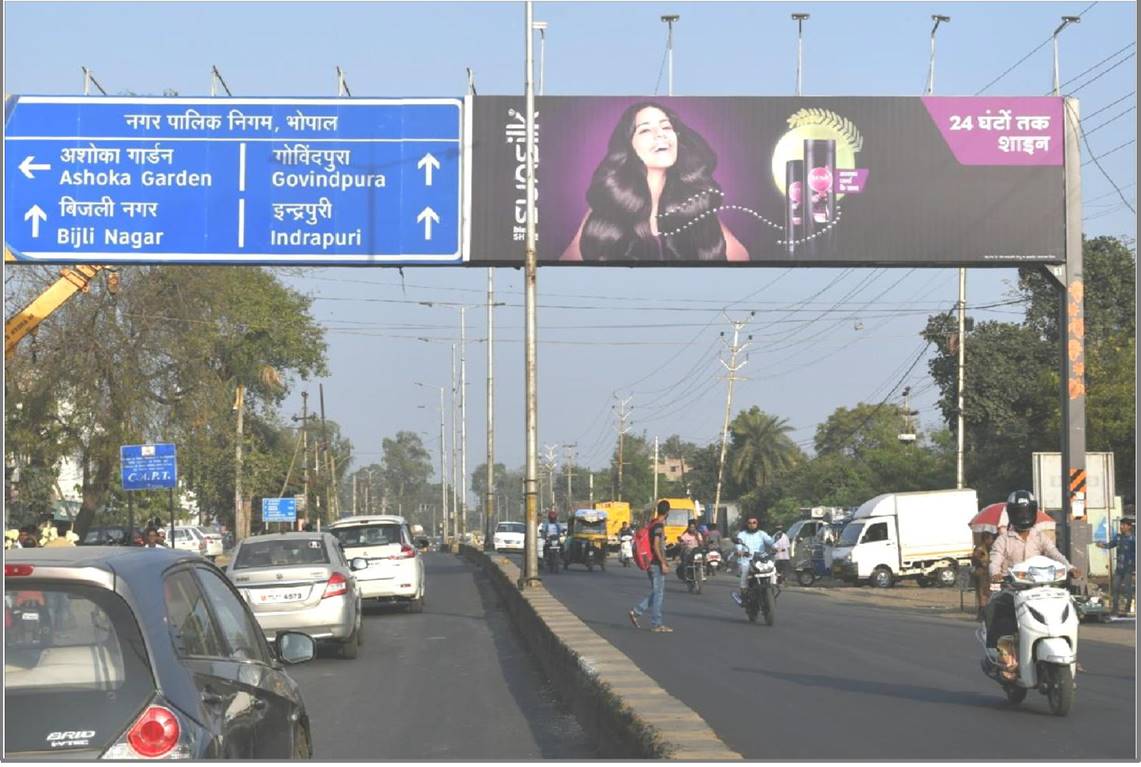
[559,102,748,263]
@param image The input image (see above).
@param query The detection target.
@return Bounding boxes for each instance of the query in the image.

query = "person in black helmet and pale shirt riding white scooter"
[985,490,1081,649]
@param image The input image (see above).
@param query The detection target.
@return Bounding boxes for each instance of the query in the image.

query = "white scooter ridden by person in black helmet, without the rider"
[976,556,1078,717]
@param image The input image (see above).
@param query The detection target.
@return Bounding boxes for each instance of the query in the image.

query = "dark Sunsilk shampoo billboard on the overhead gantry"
[467,96,1065,266]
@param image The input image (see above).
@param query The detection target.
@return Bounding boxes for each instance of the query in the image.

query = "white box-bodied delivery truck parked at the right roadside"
[832,490,979,588]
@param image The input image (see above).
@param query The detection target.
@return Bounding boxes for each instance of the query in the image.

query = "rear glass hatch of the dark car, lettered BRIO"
[3,578,154,754]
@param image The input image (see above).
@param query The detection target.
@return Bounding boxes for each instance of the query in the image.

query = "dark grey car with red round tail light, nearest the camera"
[3,547,315,761]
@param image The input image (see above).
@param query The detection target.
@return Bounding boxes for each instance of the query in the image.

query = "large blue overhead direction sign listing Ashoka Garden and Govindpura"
[5,96,463,265]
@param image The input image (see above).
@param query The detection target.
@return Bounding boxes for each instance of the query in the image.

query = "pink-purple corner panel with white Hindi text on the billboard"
[923,96,1063,165]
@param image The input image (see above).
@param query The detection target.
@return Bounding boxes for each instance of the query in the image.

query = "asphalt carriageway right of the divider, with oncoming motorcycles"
[506,552,1136,760]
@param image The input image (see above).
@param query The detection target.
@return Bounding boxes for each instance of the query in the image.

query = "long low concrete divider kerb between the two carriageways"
[460,546,742,761]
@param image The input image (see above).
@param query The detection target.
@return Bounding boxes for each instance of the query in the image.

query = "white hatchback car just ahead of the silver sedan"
[325,516,424,613]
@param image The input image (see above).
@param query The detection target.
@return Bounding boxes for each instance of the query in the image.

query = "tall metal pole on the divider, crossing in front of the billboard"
[519,0,541,588]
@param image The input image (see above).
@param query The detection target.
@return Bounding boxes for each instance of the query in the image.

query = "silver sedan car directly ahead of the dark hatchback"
[226,533,367,659]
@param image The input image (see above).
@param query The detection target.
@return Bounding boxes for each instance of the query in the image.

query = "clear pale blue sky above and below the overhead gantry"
[3,1,1136,499]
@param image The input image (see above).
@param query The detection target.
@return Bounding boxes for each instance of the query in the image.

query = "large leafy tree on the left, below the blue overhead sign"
[5,266,325,534]
